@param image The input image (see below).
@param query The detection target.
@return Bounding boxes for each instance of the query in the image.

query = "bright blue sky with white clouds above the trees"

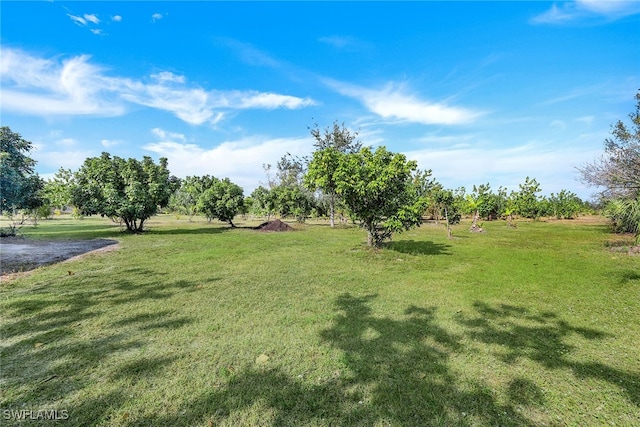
[0,0,640,199]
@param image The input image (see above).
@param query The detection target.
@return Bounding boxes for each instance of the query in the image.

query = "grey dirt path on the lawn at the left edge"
[0,238,118,275]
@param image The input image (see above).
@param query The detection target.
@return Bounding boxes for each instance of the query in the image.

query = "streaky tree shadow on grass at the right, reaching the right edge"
[458,302,640,406]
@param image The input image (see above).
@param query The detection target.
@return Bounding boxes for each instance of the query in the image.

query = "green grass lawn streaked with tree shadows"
[0,216,640,426]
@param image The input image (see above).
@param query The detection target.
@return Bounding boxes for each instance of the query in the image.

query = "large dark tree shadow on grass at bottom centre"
[141,293,541,426]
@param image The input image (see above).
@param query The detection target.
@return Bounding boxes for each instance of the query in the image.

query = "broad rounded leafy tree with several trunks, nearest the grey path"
[72,153,173,232]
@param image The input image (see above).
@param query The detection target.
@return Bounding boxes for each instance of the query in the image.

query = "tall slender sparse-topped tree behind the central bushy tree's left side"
[304,122,362,227]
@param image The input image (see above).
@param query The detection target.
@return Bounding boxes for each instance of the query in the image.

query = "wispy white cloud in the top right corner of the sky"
[531,0,640,24]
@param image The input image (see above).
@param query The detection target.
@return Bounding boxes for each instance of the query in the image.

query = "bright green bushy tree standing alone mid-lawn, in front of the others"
[336,147,426,247]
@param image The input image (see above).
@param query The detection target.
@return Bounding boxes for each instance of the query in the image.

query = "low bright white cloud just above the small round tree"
[143,134,313,191]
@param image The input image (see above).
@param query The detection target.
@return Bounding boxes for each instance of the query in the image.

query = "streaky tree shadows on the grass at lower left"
[0,269,201,425]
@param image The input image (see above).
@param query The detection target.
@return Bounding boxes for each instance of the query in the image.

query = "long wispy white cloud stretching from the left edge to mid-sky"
[0,48,315,125]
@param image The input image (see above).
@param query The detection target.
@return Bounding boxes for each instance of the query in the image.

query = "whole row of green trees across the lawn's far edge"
[0,92,640,246]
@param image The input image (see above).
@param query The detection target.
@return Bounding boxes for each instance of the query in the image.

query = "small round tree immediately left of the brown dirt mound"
[197,178,244,228]
